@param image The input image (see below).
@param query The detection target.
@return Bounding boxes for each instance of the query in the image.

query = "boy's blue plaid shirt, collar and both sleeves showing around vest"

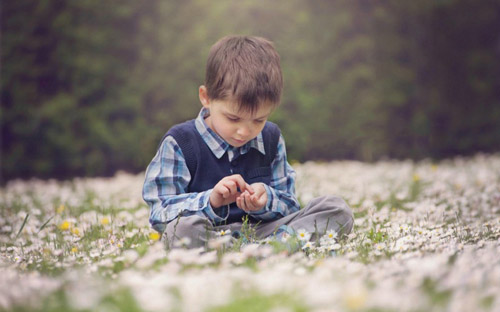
[142,108,300,232]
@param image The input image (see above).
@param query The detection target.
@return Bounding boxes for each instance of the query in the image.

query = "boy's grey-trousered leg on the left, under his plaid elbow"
[165,215,233,248]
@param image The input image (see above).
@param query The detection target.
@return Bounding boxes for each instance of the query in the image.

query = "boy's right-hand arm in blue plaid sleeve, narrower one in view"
[249,135,300,221]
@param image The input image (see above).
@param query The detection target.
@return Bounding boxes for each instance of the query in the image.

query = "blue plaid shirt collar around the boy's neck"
[195,107,266,159]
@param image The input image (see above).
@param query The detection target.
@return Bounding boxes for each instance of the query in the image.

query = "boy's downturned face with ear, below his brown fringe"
[200,86,273,147]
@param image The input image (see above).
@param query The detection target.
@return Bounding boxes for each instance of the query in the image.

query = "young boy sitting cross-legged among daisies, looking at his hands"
[143,36,353,247]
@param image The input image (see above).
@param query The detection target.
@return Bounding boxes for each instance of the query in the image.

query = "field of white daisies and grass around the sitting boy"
[0,155,500,311]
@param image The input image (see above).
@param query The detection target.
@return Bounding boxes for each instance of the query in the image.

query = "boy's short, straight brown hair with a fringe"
[205,36,283,112]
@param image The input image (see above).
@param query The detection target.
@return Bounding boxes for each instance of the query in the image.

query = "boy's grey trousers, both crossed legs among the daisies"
[165,196,354,248]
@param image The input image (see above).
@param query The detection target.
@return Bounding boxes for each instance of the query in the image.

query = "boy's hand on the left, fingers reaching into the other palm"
[210,174,254,208]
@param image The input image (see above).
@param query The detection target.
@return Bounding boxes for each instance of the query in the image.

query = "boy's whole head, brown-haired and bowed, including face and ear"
[199,36,283,147]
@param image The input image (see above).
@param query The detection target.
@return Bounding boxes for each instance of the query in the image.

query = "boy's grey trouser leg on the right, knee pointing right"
[256,195,354,239]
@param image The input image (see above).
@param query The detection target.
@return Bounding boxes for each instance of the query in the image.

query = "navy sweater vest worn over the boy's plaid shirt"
[162,119,280,224]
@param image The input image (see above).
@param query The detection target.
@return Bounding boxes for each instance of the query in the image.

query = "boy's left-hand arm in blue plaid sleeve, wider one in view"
[142,136,227,232]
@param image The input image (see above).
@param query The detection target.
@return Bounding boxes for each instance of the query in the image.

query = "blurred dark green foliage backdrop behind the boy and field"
[1,0,500,181]
